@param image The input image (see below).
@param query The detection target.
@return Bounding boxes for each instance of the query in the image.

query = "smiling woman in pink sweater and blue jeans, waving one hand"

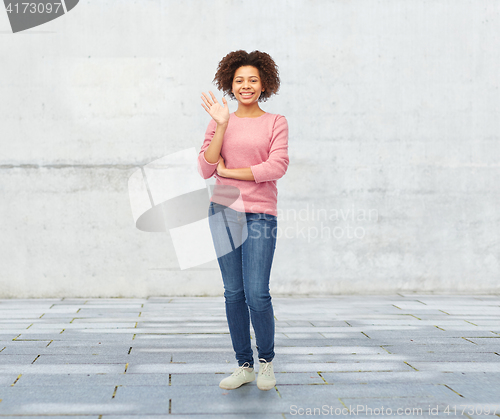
[198,50,289,390]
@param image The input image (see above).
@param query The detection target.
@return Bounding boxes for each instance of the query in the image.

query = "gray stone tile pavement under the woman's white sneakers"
[0,294,500,419]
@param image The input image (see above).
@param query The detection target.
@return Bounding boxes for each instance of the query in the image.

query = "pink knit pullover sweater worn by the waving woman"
[198,113,289,216]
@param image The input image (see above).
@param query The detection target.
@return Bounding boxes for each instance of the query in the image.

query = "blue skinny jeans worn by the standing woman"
[209,202,278,366]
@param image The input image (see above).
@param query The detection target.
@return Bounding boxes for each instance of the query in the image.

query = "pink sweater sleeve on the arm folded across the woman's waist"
[250,115,289,183]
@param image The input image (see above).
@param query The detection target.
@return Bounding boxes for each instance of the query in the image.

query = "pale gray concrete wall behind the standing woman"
[0,0,500,298]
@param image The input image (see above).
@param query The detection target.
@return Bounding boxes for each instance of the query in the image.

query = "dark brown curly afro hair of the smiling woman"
[213,50,280,102]
